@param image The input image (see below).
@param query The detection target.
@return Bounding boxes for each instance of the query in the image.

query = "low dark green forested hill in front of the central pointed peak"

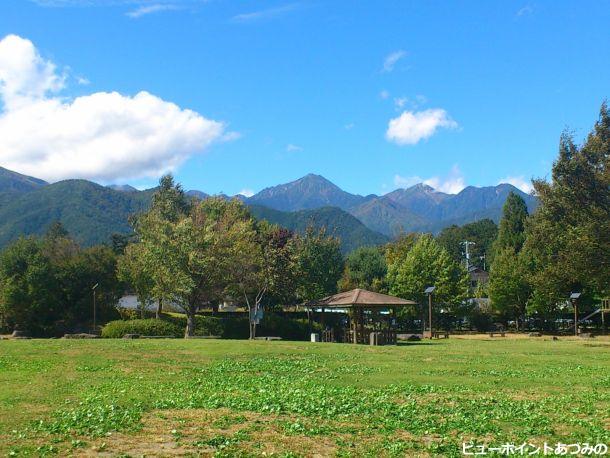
[250,205,389,253]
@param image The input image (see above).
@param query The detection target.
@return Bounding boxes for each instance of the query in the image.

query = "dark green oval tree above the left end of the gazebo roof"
[295,226,343,301]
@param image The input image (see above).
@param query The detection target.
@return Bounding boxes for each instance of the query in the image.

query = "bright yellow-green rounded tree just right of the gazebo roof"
[388,234,469,307]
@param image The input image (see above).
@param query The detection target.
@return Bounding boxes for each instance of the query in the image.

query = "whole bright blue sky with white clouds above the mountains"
[0,0,610,195]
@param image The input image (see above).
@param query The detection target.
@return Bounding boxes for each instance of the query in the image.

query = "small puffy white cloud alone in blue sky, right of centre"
[386,108,458,145]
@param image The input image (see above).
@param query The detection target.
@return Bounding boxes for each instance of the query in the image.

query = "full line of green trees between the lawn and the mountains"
[0,103,610,336]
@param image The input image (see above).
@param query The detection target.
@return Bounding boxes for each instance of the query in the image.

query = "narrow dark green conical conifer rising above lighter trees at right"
[494,191,529,253]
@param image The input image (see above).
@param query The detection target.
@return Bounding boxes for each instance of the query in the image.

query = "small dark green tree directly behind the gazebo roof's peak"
[339,247,388,292]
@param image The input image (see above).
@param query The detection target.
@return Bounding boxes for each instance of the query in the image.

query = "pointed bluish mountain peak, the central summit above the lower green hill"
[246,174,367,211]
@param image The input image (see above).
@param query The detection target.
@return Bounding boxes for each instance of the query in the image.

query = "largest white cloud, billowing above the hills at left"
[0,35,225,181]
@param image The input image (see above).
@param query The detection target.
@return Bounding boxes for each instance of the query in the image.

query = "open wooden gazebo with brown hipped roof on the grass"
[307,288,416,344]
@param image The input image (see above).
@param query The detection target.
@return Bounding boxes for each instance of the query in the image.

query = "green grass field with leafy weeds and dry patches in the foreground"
[0,337,610,456]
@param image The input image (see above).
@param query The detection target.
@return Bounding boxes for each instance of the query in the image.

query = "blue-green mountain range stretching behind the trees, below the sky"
[0,167,537,252]
